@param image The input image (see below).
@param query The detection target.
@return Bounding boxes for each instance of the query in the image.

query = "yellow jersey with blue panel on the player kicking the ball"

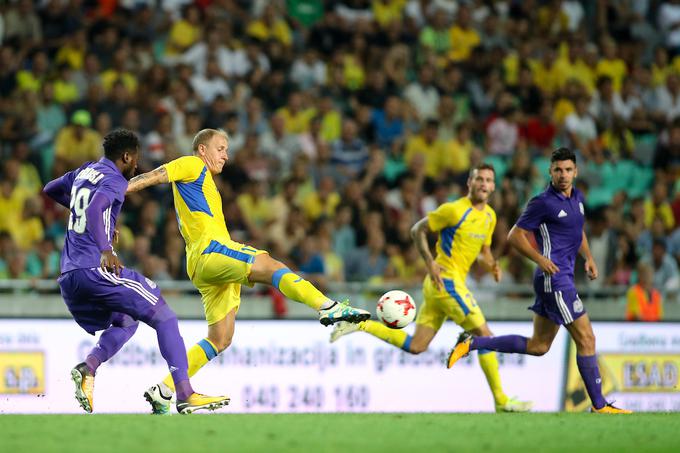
[163,156,231,278]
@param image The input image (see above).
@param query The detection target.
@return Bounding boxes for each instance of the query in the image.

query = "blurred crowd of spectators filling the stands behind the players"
[0,0,680,302]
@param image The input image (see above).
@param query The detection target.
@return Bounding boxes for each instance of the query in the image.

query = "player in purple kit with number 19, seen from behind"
[44,130,229,414]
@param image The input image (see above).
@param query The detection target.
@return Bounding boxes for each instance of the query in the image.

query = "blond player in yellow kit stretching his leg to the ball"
[122,129,371,413]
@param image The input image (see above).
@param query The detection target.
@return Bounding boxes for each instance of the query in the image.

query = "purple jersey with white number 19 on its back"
[45,157,128,273]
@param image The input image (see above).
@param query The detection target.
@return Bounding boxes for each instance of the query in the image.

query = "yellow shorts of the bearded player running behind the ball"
[416,275,486,331]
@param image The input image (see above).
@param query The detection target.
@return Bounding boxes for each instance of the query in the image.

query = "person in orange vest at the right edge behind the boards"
[626,263,663,322]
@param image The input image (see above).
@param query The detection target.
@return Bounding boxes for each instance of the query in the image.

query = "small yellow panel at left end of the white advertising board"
[0,351,45,395]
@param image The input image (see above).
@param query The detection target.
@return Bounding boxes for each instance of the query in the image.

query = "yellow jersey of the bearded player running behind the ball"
[427,197,496,280]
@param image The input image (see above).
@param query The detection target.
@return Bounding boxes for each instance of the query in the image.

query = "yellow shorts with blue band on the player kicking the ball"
[192,239,267,325]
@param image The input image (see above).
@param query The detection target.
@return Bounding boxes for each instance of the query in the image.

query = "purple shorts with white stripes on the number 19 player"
[58,268,165,335]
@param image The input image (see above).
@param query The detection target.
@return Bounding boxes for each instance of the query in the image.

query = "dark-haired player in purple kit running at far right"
[448,148,632,414]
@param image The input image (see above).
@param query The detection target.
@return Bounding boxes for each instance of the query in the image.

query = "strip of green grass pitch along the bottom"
[0,413,680,453]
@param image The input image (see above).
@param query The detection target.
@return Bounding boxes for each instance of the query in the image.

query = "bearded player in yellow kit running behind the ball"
[331,164,531,412]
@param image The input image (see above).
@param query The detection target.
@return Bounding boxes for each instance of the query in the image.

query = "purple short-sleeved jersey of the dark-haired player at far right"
[517,184,585,293]
